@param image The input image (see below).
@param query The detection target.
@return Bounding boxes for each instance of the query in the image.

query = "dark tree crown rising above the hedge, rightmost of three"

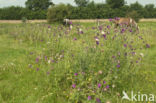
[106,0,125,9]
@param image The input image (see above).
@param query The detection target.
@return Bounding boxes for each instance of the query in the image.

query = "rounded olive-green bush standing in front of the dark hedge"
[47,4,70,23]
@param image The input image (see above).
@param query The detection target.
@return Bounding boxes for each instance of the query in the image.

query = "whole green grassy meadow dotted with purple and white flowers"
[0,22,156,103]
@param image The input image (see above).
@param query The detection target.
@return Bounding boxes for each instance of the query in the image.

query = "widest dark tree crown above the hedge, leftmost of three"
[25,0,54,11]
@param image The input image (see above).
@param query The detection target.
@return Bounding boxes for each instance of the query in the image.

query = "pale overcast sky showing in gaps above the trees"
[0,0,156,8]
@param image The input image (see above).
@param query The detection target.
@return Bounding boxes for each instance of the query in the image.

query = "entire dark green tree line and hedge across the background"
[0,0,156,22]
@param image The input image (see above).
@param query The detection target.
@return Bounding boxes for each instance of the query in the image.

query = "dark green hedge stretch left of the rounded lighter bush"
[0,6,47,20]
